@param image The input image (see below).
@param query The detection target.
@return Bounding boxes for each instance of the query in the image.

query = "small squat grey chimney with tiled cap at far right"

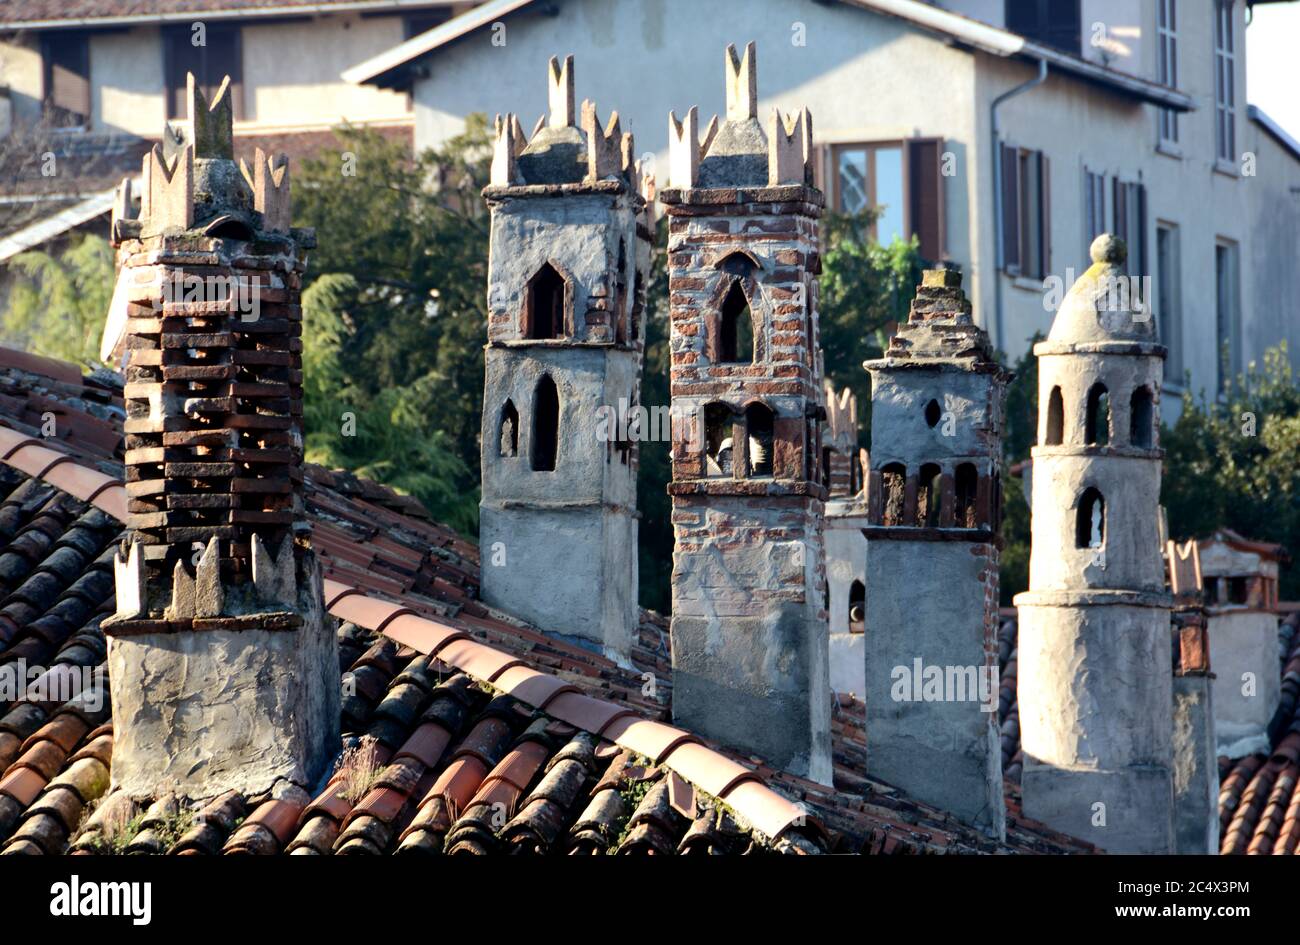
[1199,528,1286,758]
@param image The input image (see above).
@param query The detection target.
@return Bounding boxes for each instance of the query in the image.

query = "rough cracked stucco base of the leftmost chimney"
[108,552,339,798]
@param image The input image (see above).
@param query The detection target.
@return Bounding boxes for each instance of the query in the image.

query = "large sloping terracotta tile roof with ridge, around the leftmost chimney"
[0,350,1091,854]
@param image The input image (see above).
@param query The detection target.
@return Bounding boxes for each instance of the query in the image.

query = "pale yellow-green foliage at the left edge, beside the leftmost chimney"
[0,234,113,367]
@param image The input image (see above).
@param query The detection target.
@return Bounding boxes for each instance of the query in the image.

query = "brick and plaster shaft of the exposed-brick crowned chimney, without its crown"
[662,186,831,780]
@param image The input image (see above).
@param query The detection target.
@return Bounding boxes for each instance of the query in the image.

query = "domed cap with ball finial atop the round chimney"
[1048,233,1156,344]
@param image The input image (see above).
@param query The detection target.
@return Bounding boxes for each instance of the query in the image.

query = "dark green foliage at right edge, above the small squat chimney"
[1161,343,1300,601]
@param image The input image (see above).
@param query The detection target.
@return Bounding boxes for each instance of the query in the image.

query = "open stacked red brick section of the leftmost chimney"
[120,237,307,611]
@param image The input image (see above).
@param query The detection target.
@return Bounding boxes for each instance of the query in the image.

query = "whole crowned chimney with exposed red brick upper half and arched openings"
[660,43,831,784]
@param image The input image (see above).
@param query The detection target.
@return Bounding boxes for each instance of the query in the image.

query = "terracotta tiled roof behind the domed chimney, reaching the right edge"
[997,612,1300,854]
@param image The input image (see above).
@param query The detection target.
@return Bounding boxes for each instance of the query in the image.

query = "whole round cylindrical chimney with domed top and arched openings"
[1015,234,1174,853]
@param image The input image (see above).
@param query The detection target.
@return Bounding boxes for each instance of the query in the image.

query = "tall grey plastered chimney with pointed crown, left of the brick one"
[480,56,654,662]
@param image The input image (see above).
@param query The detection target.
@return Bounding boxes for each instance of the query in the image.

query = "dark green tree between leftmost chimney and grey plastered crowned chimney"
[294,116,490,532]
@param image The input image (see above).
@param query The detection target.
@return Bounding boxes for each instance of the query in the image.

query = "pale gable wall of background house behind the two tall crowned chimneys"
[415,0,976,270]
